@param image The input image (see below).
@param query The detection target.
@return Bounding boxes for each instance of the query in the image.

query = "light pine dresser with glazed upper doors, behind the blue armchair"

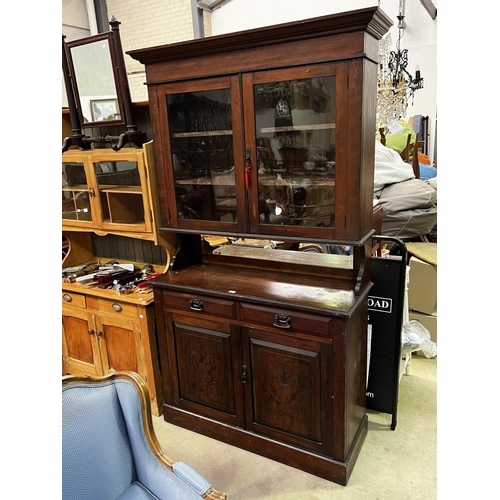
[62,142,175,415]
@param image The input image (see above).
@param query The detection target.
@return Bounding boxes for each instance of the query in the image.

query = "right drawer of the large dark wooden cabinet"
[241,304,331,337]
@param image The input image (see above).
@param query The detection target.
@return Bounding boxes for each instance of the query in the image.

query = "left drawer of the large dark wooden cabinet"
[162,291,236,318]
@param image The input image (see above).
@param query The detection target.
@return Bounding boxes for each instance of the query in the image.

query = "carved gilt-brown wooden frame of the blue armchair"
[62,371,227,500]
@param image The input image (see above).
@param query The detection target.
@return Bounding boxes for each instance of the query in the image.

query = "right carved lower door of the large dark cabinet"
[242,328,334,455]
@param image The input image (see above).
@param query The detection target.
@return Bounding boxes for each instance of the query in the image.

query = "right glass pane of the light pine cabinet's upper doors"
[94,161,144,224]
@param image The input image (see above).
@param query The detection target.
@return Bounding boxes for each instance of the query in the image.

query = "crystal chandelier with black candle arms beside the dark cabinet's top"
[377,14,424,127]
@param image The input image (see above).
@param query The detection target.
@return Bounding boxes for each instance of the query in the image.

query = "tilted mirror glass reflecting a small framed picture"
[71,40,120,123]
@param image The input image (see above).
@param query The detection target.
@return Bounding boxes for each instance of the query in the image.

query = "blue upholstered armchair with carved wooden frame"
[62,372,226,500]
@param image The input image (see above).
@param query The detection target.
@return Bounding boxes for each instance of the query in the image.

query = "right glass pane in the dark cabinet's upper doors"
[254,76,335,227]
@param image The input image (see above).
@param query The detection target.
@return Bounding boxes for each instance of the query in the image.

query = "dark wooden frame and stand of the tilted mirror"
[62,16,146,153]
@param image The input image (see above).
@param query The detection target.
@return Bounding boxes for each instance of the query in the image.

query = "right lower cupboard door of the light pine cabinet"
[96,314,148,382]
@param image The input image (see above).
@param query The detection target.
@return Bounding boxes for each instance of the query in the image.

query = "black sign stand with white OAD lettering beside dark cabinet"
[366,236,407,430]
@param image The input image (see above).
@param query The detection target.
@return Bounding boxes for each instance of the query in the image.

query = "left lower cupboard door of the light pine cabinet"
[62,306,103,375]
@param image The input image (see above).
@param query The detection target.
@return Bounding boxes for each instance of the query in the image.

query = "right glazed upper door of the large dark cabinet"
[243,65,337,240]
